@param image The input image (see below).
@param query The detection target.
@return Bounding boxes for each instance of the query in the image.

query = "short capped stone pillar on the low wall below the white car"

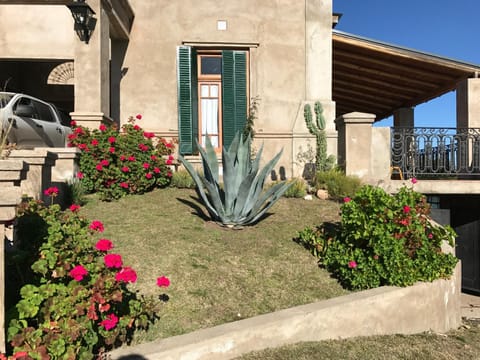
[9,148,57,201]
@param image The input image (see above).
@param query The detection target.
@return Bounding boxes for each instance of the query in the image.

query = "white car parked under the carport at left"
[0,92,72,148]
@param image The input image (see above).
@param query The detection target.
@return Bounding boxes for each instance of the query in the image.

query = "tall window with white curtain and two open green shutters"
[177,46,248,154]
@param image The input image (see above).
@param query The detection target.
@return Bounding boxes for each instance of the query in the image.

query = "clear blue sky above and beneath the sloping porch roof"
[333,0,480,127]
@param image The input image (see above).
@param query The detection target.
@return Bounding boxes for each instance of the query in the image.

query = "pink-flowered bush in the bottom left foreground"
[8,198,170,359]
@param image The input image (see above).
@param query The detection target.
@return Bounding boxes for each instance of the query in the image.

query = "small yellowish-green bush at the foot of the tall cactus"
[313,170,362,200]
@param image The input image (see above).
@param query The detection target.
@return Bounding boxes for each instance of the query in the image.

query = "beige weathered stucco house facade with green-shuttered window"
[0,0,336,177]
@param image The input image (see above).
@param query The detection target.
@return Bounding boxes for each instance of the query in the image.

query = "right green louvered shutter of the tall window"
[222,50,247,148]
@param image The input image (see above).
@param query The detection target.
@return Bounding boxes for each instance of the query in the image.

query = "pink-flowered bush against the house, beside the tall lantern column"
[69,114,175,201]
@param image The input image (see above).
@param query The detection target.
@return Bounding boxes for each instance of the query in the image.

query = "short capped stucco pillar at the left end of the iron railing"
[335,112,375,179]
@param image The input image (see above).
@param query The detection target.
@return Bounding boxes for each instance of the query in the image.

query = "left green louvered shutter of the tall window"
[177,46,198,155]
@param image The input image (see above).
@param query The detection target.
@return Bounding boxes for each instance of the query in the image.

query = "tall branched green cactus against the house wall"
[303,101,333,171]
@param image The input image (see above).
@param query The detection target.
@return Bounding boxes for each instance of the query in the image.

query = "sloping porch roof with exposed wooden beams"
[332,30,480,120]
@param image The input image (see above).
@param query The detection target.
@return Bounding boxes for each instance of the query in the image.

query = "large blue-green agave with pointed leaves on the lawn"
[178,133,291,227]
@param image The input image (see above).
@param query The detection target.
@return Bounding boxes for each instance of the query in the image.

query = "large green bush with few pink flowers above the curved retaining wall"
[298,181,457,289]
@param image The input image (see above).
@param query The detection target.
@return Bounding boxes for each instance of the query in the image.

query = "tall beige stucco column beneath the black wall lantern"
[70,0,110,128]
